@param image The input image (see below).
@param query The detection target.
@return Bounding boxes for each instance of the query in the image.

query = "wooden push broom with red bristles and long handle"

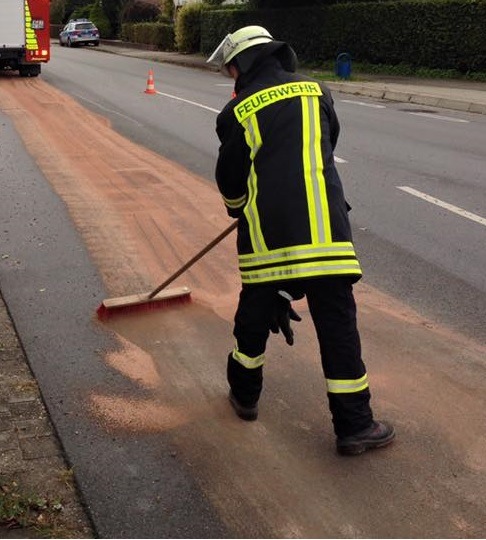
[96,220,238,320]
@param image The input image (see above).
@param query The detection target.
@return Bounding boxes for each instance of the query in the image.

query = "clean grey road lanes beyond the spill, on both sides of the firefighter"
[44,47,486,342]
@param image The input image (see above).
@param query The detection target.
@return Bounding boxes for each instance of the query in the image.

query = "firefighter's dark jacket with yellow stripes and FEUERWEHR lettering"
[216,51,361,285]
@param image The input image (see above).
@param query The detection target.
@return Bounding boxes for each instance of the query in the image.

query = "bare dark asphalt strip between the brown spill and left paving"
[0,108,227,538]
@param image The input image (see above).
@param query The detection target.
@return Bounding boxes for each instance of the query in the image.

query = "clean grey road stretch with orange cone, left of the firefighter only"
[43,46,222,178]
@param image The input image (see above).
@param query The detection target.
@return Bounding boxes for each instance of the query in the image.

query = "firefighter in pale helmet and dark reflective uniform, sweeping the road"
[208,26,395,455]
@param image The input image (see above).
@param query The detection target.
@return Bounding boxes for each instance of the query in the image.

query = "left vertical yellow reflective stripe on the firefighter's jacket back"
[244,116,268,252]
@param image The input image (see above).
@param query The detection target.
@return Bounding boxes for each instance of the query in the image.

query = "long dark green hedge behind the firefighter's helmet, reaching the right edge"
[201,0,486,72]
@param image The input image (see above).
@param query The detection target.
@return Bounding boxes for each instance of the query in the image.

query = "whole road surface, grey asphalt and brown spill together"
[0,44,486,538]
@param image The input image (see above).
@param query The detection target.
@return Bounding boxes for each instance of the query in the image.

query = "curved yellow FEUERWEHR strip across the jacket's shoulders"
[233,81,322,124]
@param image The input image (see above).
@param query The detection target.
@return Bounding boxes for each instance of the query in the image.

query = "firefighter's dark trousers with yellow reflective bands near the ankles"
[227,277,373,437]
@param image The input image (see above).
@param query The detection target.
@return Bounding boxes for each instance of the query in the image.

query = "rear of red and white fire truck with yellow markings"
[0,0,50,77]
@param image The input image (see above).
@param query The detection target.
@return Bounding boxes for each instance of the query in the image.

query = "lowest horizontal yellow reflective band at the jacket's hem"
[240,259,361,283]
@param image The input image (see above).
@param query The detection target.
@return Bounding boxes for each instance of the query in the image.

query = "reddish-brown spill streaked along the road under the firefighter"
[0,78,486,538]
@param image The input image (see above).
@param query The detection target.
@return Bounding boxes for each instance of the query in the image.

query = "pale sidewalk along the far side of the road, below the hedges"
[99,40,486,114]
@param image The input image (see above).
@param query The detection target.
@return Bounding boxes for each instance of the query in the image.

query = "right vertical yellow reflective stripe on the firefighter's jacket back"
[301,97,331,243]
